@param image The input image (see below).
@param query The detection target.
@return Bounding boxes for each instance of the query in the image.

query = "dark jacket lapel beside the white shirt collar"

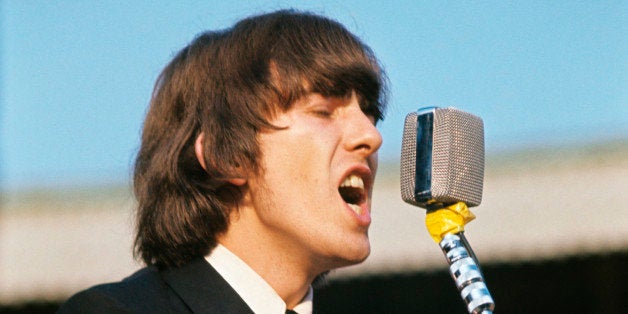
[162,258,253,313]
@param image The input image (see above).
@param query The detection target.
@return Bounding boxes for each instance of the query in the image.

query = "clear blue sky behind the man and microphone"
[0,0,628,189]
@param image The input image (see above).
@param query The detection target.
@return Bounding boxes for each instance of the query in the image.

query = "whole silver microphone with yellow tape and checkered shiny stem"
[401,107,495,313]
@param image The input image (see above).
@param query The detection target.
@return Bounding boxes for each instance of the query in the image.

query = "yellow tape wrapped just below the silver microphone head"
[425,202,475,243]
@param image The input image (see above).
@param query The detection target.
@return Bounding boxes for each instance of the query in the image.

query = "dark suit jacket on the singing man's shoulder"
[58,258,253,313]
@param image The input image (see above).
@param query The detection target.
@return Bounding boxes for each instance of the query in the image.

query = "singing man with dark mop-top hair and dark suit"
[60,11,384,314]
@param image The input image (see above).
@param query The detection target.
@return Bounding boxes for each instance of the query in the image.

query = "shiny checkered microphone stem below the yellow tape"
[439,232,495,314]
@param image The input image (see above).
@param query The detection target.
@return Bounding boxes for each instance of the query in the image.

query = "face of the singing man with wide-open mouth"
[248,94,382,271]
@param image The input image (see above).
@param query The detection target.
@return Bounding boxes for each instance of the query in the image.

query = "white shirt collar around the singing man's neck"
[205,244,314,314]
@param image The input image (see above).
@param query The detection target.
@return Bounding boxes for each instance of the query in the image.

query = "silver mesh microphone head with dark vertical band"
[401,107,484,209]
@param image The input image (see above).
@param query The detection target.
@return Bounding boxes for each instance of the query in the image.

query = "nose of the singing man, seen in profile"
[345,107,382,157]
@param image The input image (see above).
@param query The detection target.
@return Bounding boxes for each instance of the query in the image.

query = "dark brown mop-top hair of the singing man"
[134,10,385,268]
